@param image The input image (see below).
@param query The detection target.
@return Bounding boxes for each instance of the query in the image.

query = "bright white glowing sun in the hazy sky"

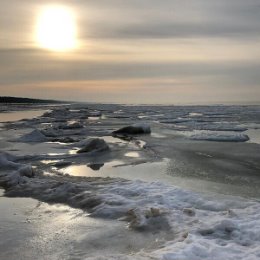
[36,6,77,52]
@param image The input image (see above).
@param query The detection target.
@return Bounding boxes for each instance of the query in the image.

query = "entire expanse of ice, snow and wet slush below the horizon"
[0,104,260,260]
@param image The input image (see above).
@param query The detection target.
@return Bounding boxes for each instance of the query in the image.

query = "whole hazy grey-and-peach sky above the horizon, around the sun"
[0,0,260,104]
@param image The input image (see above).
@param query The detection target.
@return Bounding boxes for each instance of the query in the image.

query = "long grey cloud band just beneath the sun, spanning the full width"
[0,46,260,86]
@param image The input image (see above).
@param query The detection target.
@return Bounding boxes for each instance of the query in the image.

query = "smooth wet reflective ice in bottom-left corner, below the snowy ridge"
[0,190,171,260]
